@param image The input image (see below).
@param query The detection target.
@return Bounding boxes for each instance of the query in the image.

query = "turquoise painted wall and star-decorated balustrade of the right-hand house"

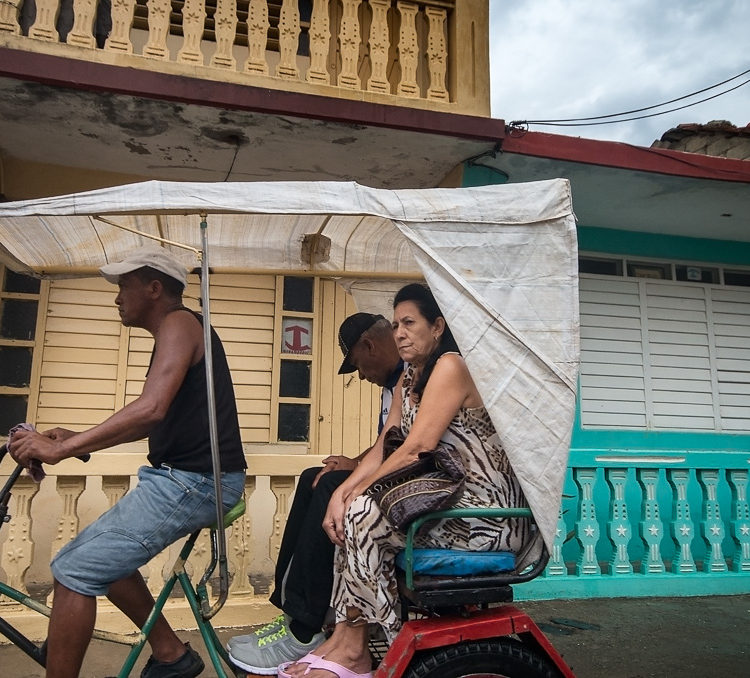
[463,165,750,599]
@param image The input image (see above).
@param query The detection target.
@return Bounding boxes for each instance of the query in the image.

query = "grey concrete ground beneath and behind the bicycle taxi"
[0,595,750,678]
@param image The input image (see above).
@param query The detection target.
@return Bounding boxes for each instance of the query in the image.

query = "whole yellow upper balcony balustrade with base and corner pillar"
[0,0,489,116]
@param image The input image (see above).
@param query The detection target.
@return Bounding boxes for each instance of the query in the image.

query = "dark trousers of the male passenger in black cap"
[270,466,351,629]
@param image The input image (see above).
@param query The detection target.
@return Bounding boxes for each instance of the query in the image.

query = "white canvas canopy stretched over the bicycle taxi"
[0,179,579,549]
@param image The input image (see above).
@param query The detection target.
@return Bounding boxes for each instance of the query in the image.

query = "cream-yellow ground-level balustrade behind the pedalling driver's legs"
[0,452,321,642]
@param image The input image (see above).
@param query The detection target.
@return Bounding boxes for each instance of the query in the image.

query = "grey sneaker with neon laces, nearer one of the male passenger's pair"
[229,623,326,676]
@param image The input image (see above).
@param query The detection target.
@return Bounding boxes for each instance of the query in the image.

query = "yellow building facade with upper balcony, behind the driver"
[0,0,499,637]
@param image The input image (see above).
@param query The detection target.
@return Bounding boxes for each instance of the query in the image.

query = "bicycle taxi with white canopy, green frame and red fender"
[0,179,579,678]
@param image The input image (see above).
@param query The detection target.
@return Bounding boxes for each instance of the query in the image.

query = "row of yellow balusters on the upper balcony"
[0,0,458,110]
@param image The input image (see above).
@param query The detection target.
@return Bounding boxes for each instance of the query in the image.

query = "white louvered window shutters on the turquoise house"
[580,259,750,432]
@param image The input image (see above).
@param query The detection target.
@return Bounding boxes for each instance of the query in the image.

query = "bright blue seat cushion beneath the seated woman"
[396,549,516,577]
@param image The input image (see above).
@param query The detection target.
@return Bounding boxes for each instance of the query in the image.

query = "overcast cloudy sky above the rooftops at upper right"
[490,0,750,146]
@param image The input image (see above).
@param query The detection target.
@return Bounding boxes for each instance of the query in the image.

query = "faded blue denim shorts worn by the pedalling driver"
[50,465,245,596]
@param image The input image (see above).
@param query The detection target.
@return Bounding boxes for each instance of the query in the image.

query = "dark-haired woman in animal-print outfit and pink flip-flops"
[279,284,529,678]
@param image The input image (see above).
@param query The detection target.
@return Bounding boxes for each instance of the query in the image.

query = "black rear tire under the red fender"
[402,637,560,678]
